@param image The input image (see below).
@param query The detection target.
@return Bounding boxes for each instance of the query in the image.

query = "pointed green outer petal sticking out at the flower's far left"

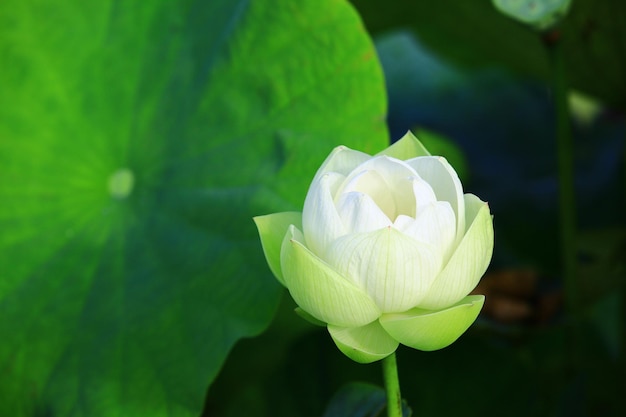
[254,211,302,285]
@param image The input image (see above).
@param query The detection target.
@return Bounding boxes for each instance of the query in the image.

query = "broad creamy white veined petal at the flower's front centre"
[326,227,441,312]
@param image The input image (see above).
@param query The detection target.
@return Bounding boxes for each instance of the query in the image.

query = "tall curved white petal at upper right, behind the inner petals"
[406,156,465,244]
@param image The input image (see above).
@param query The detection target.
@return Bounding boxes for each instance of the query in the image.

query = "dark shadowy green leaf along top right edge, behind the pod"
[351,0,626,109]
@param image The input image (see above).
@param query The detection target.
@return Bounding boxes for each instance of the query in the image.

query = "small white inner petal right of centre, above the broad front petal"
[394,201,456,262]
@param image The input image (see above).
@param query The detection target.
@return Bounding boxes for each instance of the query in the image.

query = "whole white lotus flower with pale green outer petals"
[255,132,493,363]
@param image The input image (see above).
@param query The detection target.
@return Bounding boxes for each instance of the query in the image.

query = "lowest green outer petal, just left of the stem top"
[328,321,398,363]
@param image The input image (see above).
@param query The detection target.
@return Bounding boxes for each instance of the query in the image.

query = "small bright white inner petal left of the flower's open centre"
[337,192,391,233]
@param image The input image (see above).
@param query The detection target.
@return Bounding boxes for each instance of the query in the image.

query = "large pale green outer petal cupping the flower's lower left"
[280,226,381,327]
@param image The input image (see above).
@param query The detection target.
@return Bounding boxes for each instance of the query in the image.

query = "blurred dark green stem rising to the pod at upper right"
[545,31,580,321]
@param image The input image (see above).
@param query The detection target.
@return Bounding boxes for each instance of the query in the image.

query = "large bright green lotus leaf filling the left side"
[0,0,387,417]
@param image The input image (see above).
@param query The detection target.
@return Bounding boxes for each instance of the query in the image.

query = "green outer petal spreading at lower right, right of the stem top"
[379,295,485,351]
